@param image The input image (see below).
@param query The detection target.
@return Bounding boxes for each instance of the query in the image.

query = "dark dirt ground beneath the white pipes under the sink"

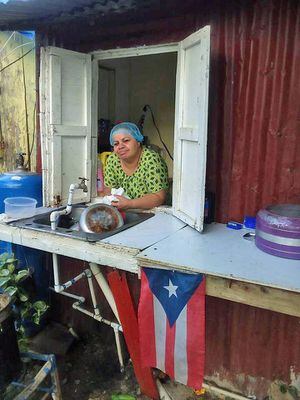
[57,334,147,400]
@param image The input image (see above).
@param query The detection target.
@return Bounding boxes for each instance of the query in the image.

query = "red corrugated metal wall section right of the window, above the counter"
[207,1,300,222]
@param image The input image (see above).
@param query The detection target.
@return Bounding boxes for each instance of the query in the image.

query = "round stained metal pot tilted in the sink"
[79,204,124,233]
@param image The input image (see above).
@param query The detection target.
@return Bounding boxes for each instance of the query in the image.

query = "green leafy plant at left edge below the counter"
[0,253,49,349]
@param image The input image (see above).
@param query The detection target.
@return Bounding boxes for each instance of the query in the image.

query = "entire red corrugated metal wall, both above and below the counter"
[35,0,300,399]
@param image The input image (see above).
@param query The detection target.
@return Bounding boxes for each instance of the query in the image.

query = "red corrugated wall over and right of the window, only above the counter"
[38,0,300,222]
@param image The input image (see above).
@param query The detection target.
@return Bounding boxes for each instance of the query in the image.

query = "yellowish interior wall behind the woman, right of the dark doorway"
[130,53,177,176]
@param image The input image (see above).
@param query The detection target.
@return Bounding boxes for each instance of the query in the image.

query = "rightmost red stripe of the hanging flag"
[187,277,205,389]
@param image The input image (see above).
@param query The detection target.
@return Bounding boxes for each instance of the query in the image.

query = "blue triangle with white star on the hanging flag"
[143,268,203,326]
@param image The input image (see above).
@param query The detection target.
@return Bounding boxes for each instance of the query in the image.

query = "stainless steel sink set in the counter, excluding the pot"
[10,204,154,242]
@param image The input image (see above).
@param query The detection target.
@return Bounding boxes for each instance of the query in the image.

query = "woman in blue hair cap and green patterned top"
[104,122,168,210]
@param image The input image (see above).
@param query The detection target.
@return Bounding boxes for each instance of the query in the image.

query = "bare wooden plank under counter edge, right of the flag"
[206,276,300,317]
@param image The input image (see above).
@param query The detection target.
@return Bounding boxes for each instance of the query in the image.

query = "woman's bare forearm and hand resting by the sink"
[112,189,166,210]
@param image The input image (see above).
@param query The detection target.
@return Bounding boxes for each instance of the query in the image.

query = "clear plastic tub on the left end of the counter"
[4,197,37,218]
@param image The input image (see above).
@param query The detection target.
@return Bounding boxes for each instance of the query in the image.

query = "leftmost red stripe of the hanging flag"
[138,271,156,367]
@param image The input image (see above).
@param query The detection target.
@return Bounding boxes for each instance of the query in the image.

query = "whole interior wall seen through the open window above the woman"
[99,53,177,177]
